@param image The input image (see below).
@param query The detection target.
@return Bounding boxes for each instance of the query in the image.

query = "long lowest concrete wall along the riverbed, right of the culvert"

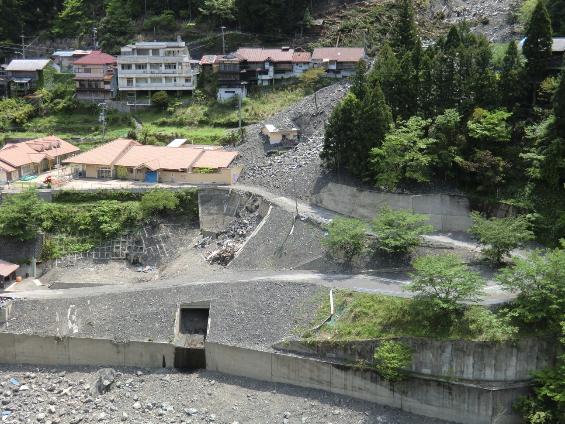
[206,343,528,424]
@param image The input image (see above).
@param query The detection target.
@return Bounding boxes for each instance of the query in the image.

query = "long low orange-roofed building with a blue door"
[65,138,241,184]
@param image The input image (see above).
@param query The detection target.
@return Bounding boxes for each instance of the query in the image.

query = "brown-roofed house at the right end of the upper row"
[312,47,367,78]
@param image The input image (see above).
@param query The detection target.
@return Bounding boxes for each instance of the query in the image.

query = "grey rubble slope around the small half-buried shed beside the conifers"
[232,81,349,199]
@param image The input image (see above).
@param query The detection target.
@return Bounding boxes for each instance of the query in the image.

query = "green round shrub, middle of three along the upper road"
[371,207,433,254]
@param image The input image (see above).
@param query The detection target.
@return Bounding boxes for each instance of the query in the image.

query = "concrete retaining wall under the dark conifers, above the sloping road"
[311,183,472,232]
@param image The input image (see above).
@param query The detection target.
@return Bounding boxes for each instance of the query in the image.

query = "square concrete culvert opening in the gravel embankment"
[174,302,210,370]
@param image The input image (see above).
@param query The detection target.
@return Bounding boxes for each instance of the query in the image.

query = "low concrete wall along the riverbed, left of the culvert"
[0,333,175,368]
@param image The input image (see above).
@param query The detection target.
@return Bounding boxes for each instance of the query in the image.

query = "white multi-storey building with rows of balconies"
[118,40,199,105]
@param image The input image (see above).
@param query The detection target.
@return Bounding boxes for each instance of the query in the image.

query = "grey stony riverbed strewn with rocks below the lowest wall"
[0,366,450,424]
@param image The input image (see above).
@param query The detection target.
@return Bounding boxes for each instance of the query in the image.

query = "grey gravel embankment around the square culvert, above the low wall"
[0,279,327,350]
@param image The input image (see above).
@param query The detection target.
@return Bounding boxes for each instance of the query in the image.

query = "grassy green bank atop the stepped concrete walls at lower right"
[303,290,520,342]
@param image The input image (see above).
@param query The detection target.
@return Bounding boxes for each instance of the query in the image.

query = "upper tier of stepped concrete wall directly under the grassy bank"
[275,337,556,382]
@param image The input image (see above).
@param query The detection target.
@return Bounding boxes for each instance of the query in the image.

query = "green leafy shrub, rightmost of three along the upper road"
[469,212,534,265]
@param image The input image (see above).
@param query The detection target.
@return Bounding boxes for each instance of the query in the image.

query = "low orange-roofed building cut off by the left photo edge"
[0,136,80,183]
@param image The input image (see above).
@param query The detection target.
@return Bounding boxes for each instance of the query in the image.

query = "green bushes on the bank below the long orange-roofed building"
[0,189,198,259]
